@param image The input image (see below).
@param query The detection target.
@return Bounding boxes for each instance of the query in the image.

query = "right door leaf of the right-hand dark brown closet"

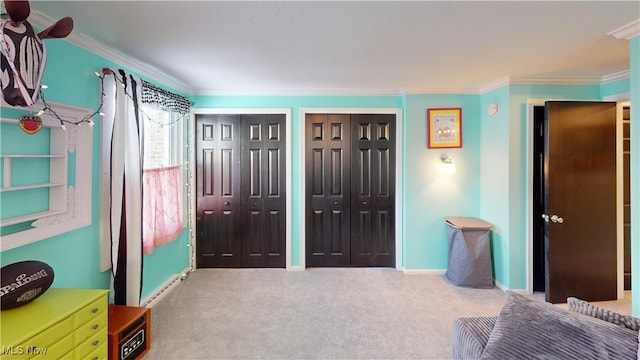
[351,114,396,266]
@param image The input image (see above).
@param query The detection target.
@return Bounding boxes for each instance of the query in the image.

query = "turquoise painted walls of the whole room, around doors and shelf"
[0,31,640,304]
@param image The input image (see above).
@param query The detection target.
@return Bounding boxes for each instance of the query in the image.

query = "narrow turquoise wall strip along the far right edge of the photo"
[629,36,640,317]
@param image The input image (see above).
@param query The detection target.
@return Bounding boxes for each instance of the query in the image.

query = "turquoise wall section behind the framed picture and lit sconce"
[402,95,480,270]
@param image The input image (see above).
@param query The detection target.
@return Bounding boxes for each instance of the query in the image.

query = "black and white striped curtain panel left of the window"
[101,69,143,306]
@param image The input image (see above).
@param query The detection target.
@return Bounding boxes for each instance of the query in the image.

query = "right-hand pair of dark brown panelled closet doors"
[305,114,396,267]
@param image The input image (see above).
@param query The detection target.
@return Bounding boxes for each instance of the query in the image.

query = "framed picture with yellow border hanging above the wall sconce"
[427,108,462,149]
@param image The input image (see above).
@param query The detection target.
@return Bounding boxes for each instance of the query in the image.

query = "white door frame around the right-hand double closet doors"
[300,108,404,270]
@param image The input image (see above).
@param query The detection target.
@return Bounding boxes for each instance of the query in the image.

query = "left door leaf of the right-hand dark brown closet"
[305,114,351,266]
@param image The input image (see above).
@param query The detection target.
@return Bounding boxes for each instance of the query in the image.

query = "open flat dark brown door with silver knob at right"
[544,101,617,303]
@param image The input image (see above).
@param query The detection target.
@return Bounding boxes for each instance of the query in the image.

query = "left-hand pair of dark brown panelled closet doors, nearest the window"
[195,114,286,268]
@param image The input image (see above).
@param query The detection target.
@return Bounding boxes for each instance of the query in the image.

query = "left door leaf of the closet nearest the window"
[196,114,242,267]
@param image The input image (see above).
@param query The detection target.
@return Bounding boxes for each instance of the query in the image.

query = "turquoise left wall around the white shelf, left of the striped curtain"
[0,40,113,289]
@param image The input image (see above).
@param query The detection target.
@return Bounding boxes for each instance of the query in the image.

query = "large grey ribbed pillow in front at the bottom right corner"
[481,292,638,360]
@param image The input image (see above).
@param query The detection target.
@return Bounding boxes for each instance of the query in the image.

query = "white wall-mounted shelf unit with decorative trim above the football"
[0,102,93,251]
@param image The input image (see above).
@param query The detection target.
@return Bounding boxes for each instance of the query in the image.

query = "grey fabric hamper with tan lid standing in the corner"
[445,216,493,288]
